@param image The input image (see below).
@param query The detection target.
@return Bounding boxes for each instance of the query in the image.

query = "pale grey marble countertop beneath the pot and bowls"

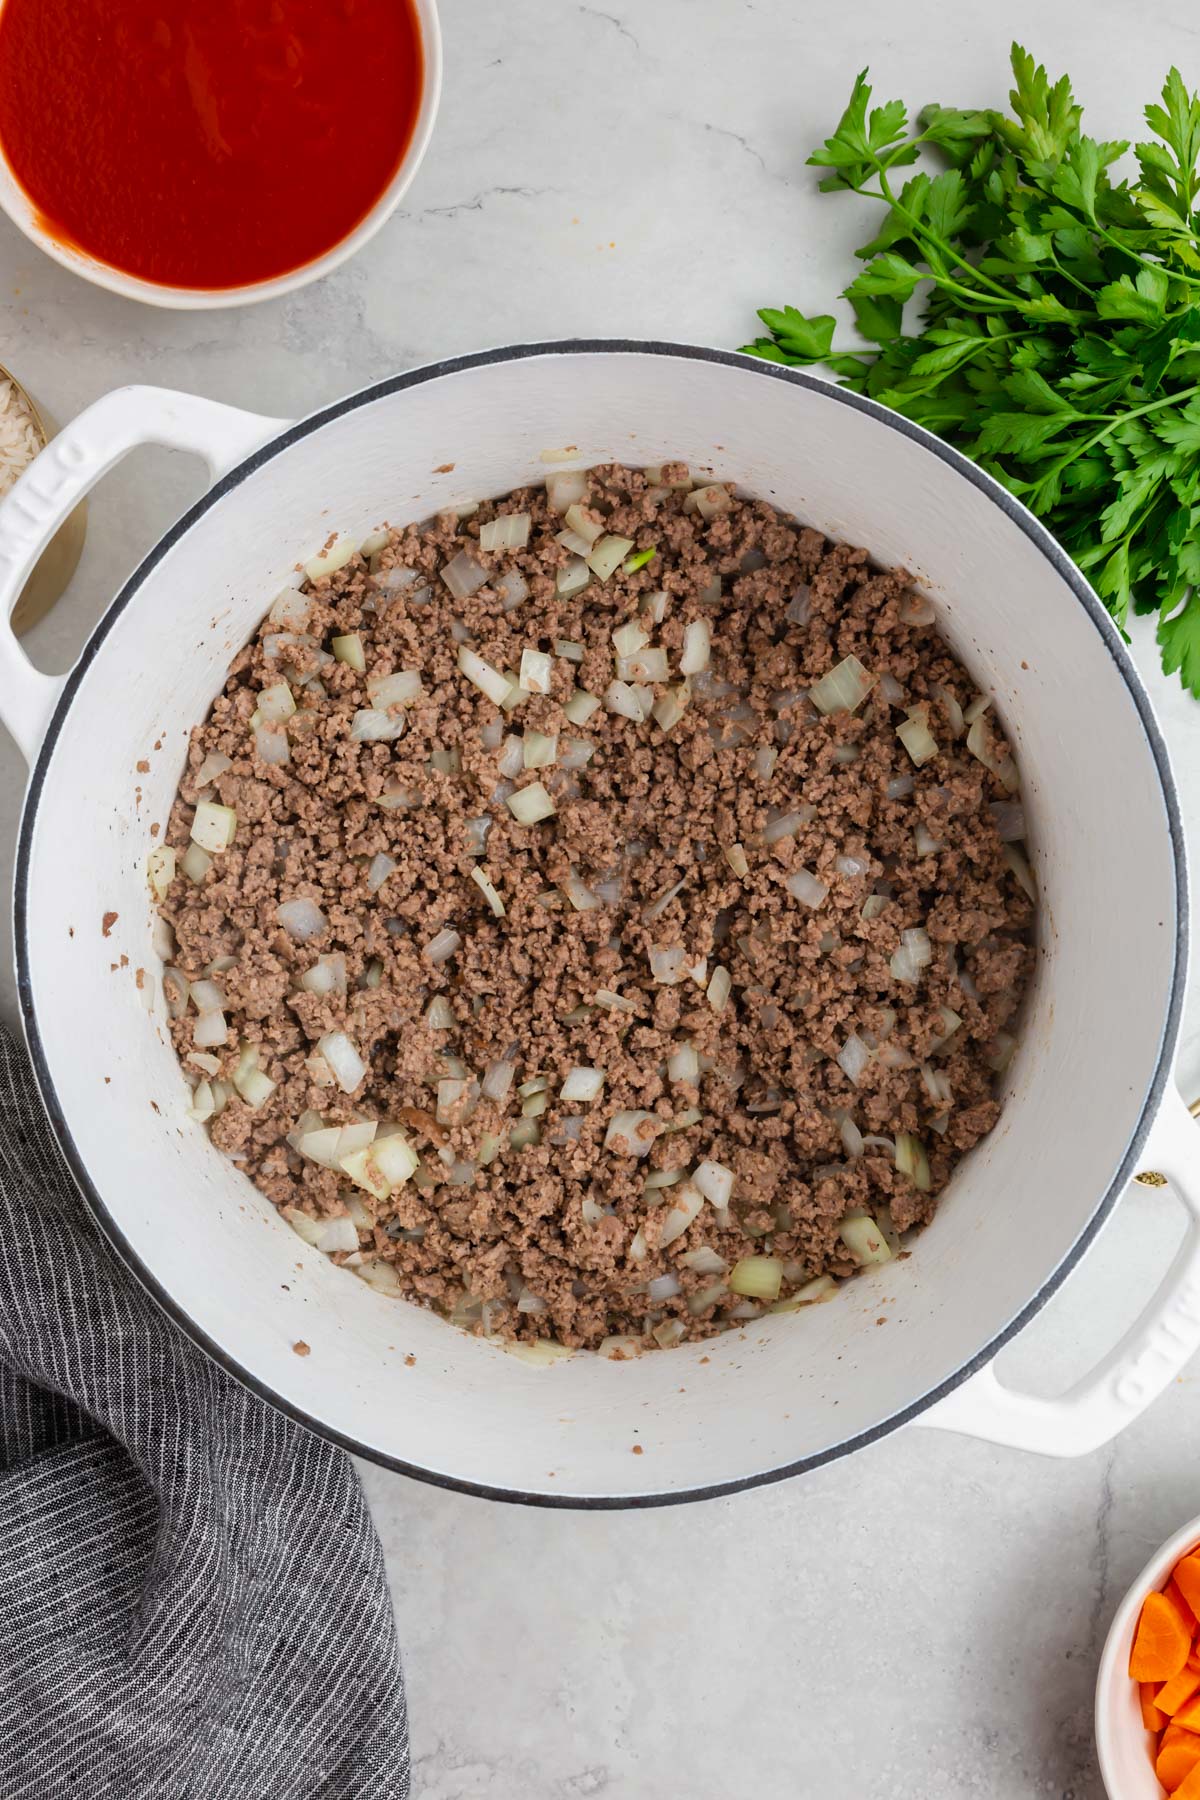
[0,0,1200,1800]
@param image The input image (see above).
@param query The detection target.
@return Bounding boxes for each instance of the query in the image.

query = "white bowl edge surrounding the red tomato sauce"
[0,0,441,311]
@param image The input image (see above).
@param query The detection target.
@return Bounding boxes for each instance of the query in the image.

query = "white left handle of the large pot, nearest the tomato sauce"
[0,387,290,763]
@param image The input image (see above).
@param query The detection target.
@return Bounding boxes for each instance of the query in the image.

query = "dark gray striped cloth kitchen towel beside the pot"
[0,1028,408,1800]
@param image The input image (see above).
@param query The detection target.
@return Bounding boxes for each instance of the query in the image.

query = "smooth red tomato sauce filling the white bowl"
[0,0,425,288]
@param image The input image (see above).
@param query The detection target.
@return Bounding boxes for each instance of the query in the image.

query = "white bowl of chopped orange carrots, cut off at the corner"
[1096,1519,1200,1800]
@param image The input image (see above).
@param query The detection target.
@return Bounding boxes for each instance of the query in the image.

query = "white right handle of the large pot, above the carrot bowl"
[916,1087,1200,1456]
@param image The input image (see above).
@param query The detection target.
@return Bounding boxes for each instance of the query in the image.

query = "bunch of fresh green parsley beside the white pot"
[745,45,1200,697]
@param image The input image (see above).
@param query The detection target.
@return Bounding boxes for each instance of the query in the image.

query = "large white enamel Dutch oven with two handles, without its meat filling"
[0,344,1200,1507]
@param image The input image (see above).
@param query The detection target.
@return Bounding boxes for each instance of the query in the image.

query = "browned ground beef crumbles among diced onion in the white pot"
[162,464,1033,1346]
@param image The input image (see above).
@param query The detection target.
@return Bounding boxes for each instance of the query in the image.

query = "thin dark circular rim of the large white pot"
[14,338,1189,1510]
